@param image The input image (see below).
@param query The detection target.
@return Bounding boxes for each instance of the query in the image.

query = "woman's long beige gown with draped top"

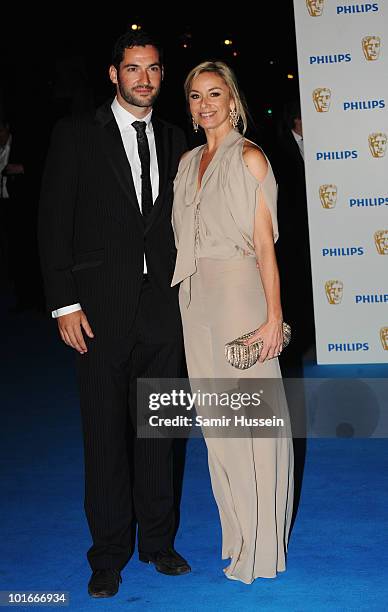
[172,130,293,584]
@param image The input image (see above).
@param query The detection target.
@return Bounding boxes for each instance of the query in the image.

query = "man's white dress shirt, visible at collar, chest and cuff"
[51,98,159,319]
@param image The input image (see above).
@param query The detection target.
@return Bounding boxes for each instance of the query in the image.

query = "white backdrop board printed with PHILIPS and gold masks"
[294,0,388,364]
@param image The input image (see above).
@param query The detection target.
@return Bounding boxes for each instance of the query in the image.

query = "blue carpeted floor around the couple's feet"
[0,296,388,612]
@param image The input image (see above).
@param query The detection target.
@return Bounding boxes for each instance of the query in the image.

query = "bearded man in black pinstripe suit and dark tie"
[39,33,190,597]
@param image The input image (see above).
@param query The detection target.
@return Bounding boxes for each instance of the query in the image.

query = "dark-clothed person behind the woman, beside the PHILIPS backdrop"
[273,98,314,377]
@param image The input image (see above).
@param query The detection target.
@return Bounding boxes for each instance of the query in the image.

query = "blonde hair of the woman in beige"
[184,61,248,134]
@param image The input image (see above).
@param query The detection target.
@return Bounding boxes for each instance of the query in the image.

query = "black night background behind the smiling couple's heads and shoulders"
[0,8,304,312]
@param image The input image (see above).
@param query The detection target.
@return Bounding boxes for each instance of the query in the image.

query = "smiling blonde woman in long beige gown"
[172,62,293,584]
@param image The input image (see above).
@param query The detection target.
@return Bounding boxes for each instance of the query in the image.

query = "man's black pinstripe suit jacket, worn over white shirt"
[39,102,186,333]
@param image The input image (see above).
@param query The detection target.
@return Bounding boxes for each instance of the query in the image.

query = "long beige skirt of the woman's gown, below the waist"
[179,257,293,584]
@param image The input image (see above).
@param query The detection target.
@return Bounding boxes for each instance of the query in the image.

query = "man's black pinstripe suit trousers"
[77,278,182,570]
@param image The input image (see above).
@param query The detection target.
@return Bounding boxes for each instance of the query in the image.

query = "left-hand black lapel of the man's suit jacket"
[96,103,142,218]
